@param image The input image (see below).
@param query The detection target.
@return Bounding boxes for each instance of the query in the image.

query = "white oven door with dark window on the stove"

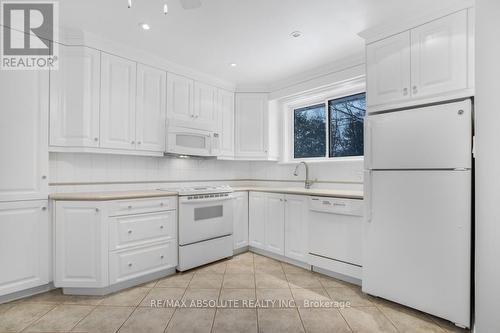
[179,194,233,246]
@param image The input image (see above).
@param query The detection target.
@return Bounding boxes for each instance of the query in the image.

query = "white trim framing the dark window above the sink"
[280,76,366,164]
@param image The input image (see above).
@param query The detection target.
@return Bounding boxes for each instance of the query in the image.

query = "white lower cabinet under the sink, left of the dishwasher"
[249,192,308,262]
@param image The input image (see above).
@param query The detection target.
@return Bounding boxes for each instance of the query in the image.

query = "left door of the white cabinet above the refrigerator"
[366,31,411,106]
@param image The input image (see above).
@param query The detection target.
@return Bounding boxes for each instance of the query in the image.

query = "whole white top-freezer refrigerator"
[362,99,472,327]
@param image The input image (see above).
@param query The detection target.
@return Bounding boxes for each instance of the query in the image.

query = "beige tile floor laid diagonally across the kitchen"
[0,252,465,333]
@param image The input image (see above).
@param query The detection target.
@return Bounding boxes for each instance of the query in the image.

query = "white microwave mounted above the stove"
[165,127,220,157]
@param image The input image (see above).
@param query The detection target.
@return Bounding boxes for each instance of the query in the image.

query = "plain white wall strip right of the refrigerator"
[475,0,500,333]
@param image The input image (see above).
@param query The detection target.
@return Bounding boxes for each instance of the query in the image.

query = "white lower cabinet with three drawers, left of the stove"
[54,197,177,293]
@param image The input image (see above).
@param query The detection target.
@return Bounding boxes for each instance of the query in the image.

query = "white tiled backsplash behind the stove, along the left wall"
[49,153,250,192]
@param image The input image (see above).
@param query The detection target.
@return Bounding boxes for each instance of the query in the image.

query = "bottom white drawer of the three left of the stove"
[109,239,177,284]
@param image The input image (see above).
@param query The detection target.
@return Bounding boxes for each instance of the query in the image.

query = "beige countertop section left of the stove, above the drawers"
[49,190,177,201]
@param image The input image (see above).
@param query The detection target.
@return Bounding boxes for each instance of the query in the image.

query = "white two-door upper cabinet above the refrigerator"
[366,9,474,112]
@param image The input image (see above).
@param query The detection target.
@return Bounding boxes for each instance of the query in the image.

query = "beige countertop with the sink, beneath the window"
[232,186,363,199]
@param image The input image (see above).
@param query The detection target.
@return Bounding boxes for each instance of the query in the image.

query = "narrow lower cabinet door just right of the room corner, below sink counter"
[248,192,266,249]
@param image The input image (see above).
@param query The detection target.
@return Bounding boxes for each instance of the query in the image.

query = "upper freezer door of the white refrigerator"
[365,100,472,170]
